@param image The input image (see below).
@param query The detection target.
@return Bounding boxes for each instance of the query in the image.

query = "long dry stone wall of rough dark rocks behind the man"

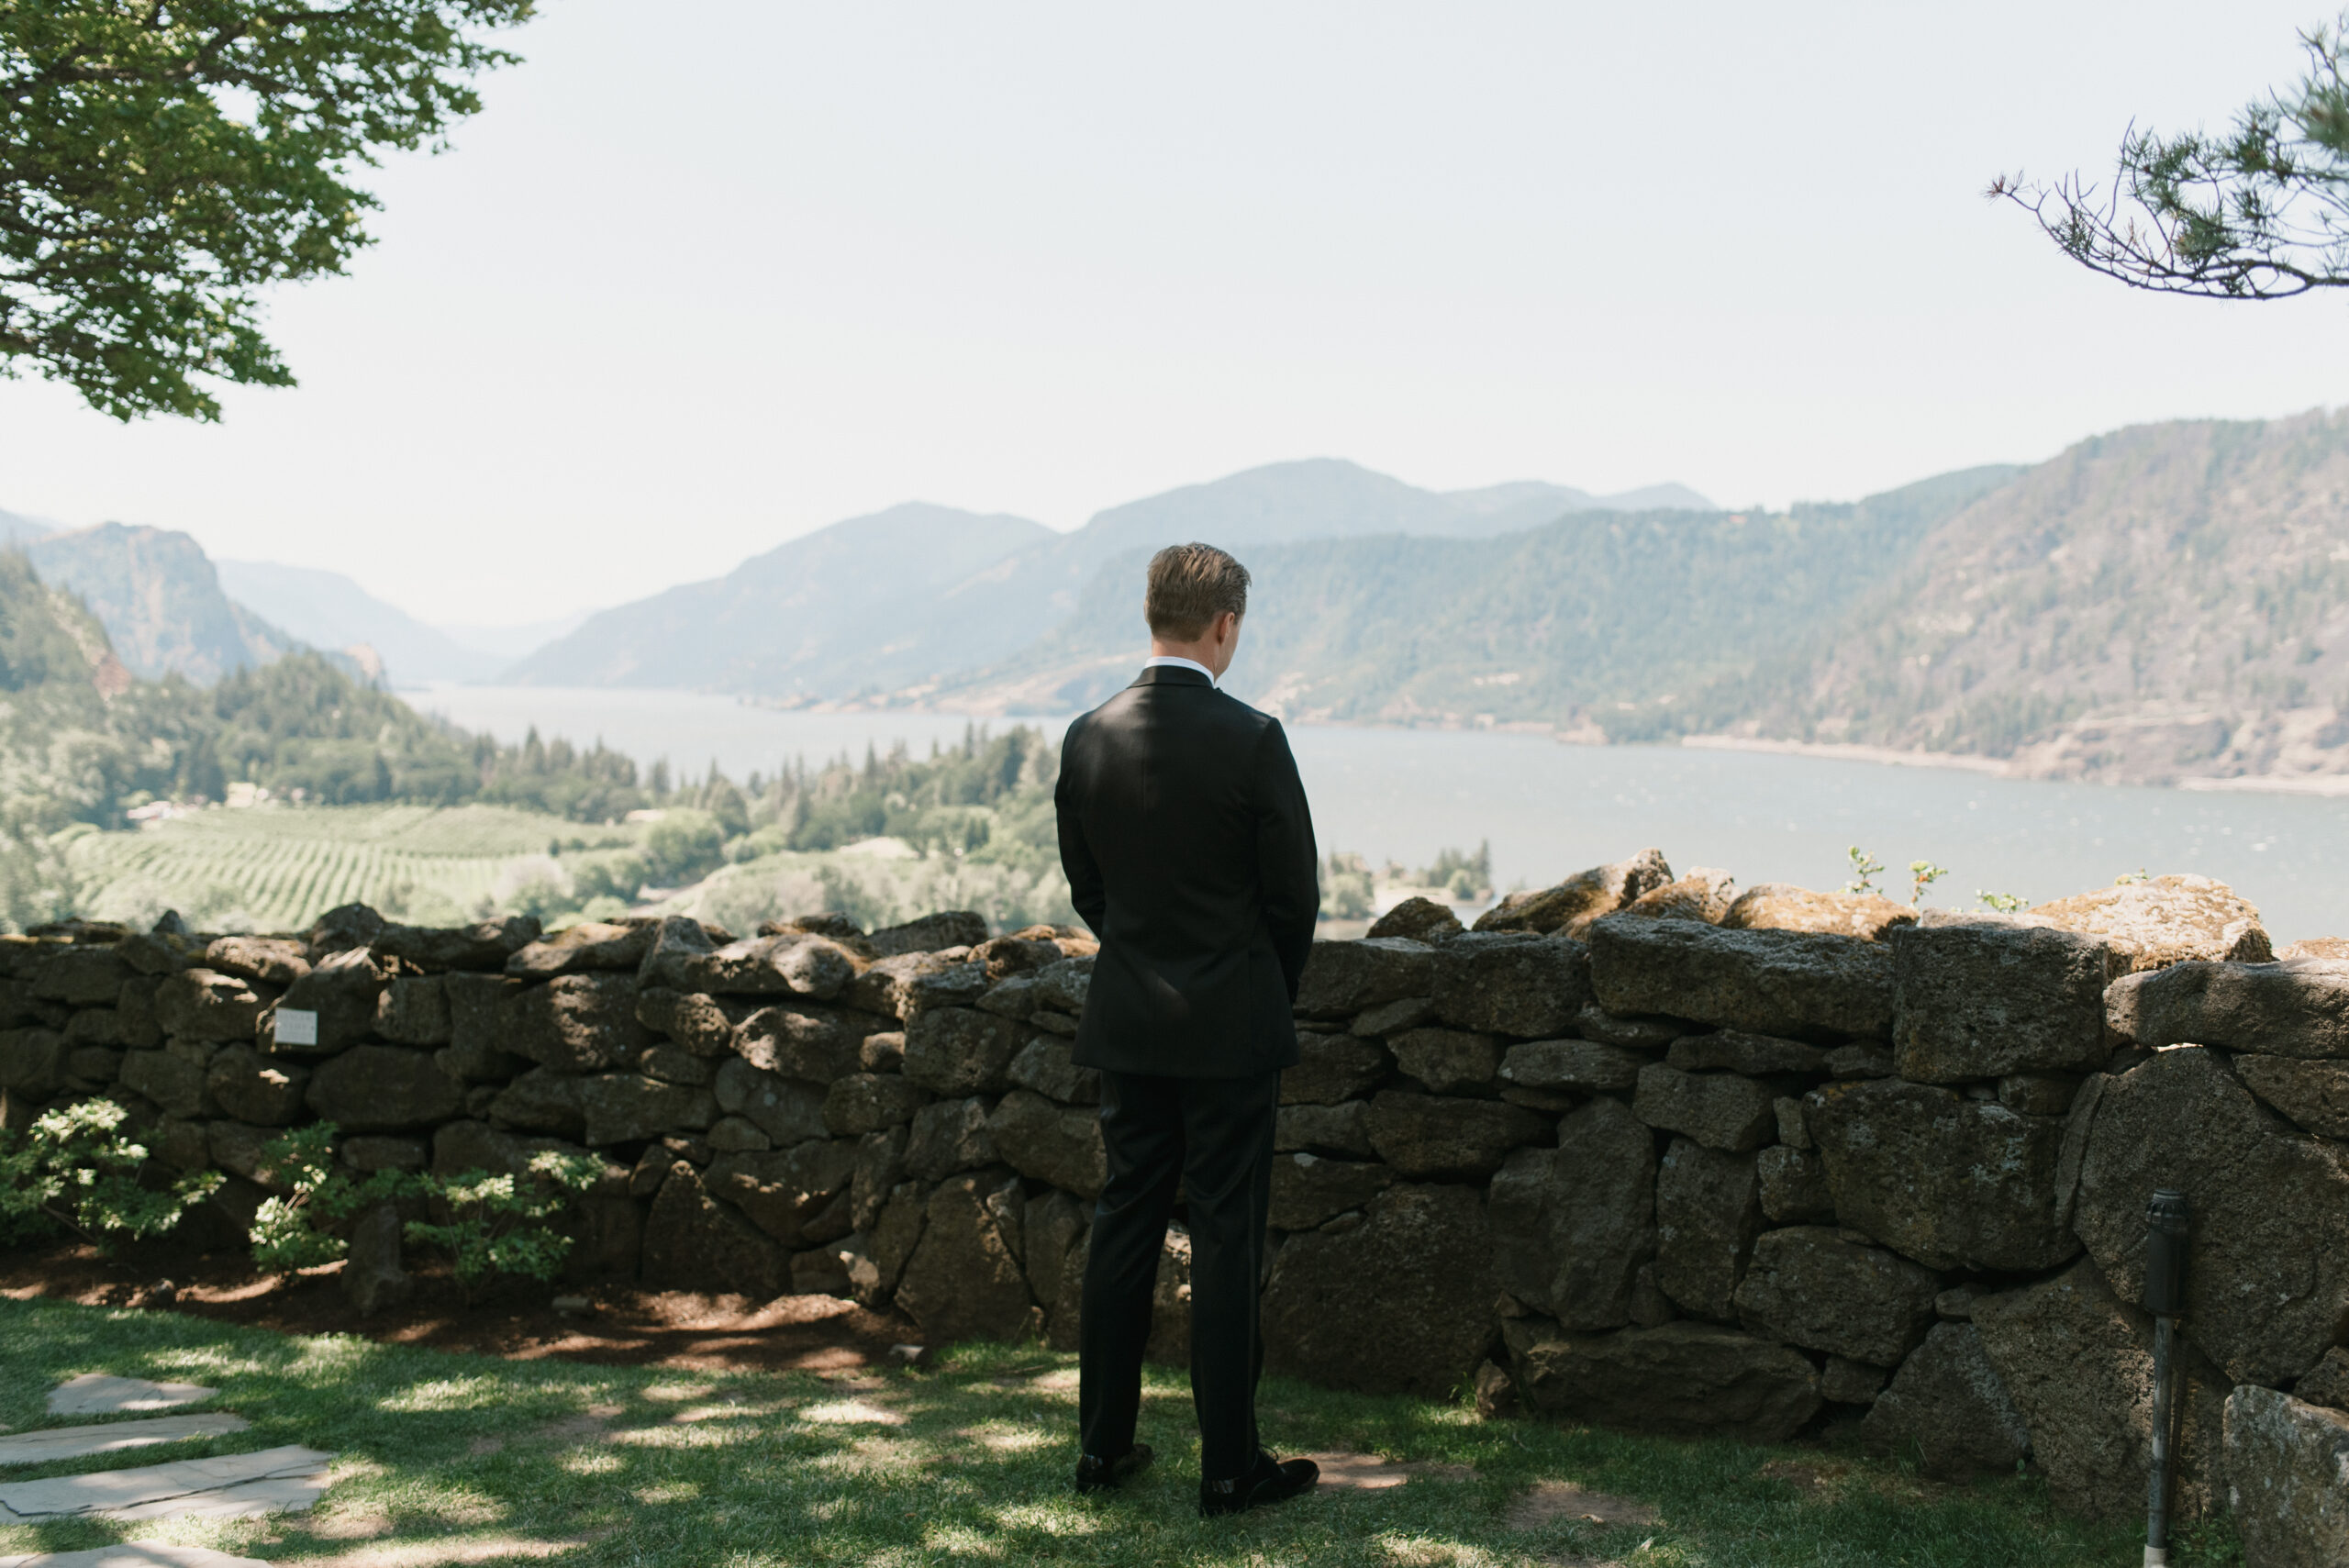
[0,852,2349,1568]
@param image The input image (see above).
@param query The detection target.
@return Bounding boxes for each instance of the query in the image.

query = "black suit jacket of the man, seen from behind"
[1054,664,1320,1077]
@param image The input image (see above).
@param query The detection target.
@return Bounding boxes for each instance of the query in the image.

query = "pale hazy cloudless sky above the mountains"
[0,0,2349,622]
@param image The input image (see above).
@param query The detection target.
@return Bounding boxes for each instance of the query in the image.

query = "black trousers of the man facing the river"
[1078,1071,1280,1481]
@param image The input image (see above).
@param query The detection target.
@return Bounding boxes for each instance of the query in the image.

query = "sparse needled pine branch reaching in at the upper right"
[1989,12,2349,300]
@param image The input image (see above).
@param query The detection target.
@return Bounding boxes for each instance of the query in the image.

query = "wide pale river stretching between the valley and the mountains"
[402,685,2349,943]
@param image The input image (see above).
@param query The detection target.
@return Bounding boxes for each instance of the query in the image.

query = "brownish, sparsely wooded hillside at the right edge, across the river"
[1703,411,2349,782]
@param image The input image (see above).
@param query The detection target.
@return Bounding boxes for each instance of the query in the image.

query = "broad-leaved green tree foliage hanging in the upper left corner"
[0,0,533,420]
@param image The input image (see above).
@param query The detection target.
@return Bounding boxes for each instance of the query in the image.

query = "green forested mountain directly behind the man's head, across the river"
[937,465,2022,728]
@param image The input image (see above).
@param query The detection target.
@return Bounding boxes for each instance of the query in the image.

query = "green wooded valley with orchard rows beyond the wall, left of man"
[0,551,1069,929]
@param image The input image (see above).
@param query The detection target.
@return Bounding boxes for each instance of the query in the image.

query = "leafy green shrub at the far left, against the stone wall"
[0,1101,223,1251]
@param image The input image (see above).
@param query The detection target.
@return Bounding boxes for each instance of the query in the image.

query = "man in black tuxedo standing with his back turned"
[1054,545,1320,1514]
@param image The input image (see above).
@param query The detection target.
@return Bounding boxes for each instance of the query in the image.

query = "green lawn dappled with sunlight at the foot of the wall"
[0,1300,2234,1568]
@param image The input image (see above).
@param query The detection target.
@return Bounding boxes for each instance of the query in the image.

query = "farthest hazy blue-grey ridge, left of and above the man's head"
[510,458,1712,702]
